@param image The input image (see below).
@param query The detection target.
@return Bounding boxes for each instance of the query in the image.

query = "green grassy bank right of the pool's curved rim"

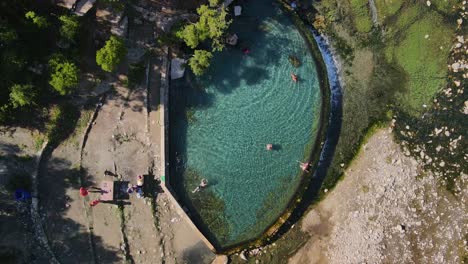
[315,0,454,189]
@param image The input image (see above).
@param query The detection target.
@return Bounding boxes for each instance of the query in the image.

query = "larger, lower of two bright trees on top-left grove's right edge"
[49,59,79,95]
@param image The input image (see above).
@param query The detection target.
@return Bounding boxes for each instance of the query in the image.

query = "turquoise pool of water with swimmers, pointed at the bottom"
[170,0,321,247]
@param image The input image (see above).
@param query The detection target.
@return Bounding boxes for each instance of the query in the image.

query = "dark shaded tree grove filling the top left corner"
[0,0,82,126]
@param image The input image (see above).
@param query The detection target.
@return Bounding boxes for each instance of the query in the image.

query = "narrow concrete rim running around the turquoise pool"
[161,0,330,254]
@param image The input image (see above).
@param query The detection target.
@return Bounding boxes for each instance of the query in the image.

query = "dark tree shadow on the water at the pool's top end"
[198,3,289,94]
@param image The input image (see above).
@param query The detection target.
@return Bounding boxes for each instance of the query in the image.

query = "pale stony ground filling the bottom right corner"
[289,129,468,263]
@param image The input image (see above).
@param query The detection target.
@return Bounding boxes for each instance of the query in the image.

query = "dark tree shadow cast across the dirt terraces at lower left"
[38,154,123,263]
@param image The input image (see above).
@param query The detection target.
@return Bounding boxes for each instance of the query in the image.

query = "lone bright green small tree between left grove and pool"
[96,36,127,72]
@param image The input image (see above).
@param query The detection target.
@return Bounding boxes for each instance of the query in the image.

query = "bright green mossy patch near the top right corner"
[394,13,454,115]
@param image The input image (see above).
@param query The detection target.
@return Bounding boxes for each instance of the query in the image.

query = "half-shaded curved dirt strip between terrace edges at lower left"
[38,144,94,263]
